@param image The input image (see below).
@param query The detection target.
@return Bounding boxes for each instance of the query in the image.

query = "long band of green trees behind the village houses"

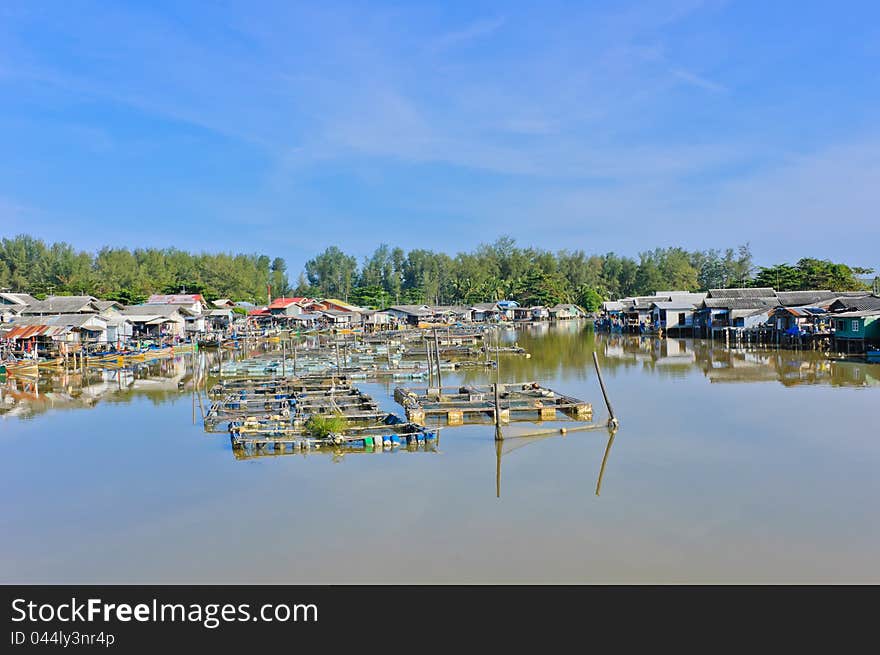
[0,235,873,310]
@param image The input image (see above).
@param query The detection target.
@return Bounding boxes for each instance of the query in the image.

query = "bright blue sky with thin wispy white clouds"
[0,0,880,271]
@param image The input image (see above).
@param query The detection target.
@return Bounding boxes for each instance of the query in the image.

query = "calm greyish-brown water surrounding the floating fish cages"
[0,323,880,583]
